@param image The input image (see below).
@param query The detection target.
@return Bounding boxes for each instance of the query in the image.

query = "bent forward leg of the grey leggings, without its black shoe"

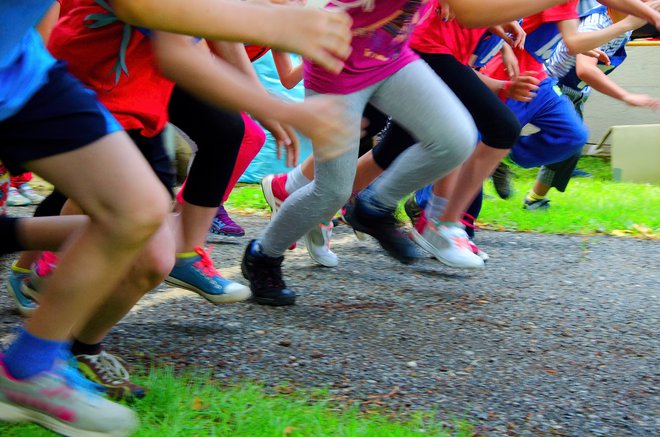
[367,61,476,210]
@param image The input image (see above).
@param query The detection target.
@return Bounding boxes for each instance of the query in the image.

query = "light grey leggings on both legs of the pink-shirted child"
[261,60,477,257]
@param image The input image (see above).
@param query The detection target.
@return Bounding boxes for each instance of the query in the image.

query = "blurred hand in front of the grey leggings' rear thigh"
[287,95,360,161]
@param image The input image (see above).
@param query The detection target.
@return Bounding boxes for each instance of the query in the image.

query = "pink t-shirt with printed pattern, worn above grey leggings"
[304,0,425,94]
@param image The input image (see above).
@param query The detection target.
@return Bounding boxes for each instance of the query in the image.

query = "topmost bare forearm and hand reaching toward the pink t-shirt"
[112,0,351,73]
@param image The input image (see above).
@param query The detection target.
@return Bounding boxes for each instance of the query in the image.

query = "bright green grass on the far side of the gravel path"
[227,157,660,238]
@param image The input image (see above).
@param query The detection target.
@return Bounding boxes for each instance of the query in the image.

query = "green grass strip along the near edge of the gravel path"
[0,369,473,437]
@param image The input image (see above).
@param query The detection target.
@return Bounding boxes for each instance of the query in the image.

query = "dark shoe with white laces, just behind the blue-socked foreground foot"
[75,351,146,400]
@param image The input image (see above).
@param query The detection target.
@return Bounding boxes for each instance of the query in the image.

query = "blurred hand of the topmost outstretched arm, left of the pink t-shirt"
[273,6,351,74]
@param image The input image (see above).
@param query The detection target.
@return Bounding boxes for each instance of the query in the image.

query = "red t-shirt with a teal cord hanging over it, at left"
[48,0,174,137]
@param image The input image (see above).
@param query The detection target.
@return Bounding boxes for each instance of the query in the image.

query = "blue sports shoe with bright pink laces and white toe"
[165,247,250,303]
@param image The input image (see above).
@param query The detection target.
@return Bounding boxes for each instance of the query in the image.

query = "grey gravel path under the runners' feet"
[0,209,660,436]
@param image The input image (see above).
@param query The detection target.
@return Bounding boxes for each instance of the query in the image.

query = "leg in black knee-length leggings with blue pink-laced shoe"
[167,85,250,303]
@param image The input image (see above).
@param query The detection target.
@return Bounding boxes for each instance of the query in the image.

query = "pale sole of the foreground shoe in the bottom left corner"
[0,401,139,437]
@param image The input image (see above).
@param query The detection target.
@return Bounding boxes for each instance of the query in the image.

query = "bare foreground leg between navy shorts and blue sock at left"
[26,132,169,340]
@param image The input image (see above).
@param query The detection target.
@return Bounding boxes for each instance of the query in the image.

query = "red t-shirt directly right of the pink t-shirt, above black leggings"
[410,0,487,65]
